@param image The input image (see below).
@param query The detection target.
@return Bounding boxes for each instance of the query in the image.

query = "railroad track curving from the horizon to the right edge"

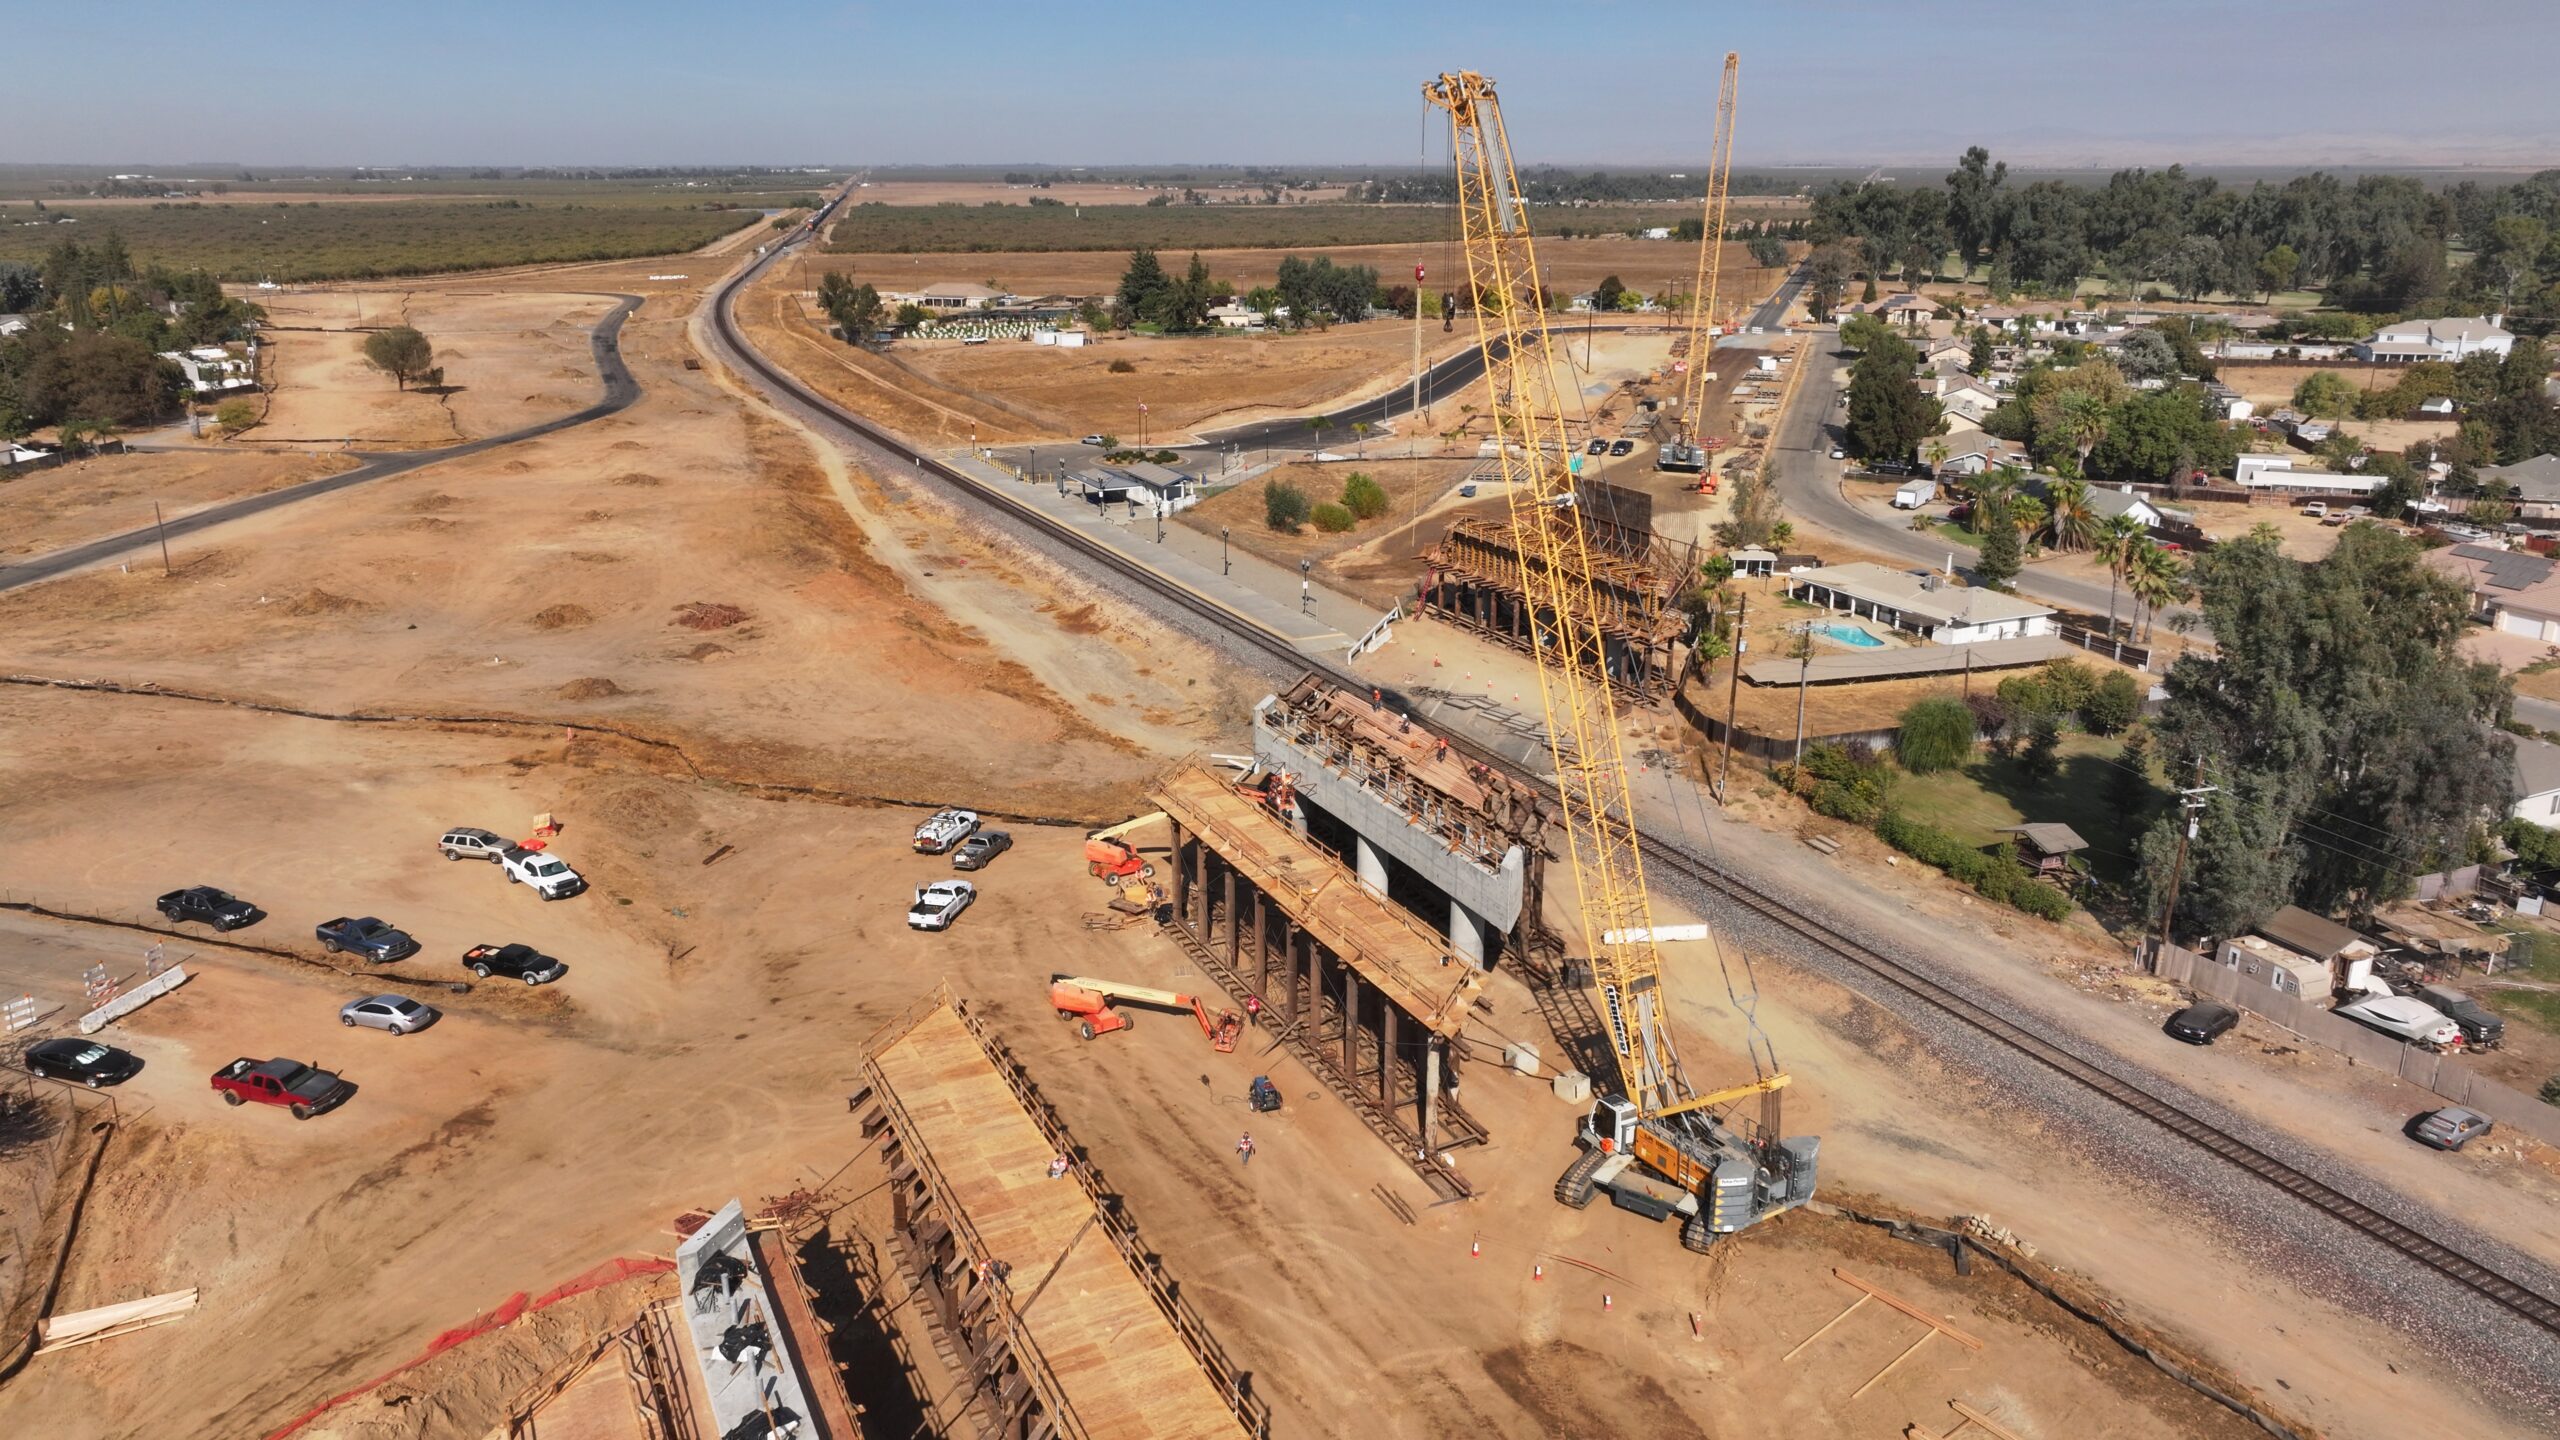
[712,233,2560,1335]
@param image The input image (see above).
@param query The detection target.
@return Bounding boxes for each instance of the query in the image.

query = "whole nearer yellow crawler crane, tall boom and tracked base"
[1423,56,1820,1250]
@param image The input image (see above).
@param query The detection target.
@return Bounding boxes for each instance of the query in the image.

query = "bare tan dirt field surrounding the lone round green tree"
[241,287,612,451]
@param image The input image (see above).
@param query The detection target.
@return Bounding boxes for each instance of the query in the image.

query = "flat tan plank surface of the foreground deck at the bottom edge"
[873,1007,1242,1440]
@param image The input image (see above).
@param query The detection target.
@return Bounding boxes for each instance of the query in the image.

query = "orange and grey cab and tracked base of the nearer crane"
[1556,1094,1823,1253]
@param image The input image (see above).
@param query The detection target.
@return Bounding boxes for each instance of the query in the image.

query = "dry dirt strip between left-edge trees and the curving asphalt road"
[0,451,353,564]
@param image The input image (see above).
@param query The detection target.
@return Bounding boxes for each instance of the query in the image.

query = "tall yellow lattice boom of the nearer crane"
[1423,72,1695,1115]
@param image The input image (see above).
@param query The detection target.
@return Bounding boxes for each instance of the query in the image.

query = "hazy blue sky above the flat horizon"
[20,0,2560,167]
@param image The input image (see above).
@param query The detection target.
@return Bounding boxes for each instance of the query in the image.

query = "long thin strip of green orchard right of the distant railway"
[827,200,1697,254]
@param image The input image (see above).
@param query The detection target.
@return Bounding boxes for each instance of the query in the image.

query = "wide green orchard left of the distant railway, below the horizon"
[0,197,760,282]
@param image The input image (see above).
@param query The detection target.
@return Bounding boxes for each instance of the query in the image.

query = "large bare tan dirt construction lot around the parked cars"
[0,219,2496,1440]
